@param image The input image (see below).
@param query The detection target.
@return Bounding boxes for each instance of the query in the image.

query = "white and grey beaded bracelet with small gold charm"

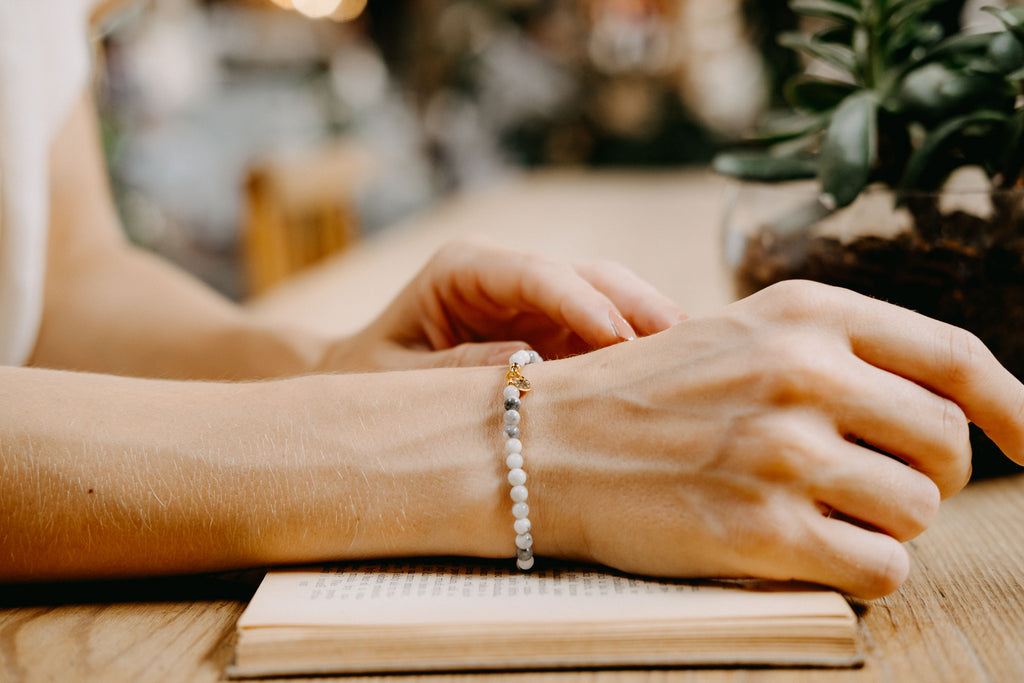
[502,350,542,571]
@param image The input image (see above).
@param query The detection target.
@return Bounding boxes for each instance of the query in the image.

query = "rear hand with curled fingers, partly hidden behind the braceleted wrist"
[327,238,685,370]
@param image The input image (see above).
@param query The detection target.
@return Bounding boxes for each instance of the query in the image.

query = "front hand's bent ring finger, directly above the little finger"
[811,439,940,542]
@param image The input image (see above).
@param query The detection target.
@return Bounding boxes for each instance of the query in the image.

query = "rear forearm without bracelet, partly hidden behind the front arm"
[31,240,327,380]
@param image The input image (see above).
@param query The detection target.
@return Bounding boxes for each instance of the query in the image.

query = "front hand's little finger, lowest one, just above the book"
[791,512,910,599]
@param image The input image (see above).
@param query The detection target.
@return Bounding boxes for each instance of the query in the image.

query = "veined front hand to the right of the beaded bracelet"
[523,282,1024,598]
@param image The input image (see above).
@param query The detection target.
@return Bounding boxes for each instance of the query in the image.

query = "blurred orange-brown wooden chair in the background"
[242,141,374,295]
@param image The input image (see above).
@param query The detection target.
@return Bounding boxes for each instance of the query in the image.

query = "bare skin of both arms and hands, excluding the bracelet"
[0,94,1024,597]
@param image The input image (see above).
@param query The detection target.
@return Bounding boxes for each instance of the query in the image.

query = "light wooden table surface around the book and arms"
[0,173,1024,683]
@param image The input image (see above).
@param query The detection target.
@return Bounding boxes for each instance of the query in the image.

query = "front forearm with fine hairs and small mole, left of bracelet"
[0,362,511,581]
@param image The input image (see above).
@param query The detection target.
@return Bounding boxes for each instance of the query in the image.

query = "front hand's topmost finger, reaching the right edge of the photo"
[835,286,1024,464]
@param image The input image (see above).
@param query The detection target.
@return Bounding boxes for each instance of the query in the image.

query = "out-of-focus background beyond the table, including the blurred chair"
[97,0,798,299]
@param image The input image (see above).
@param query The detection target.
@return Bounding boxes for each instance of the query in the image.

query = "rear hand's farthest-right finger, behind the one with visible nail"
[575,261,686,335]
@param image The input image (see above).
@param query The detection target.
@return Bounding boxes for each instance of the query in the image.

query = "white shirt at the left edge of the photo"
[0,0,91,366]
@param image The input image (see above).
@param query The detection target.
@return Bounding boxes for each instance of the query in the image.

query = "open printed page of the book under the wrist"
[239,561,856,628]
